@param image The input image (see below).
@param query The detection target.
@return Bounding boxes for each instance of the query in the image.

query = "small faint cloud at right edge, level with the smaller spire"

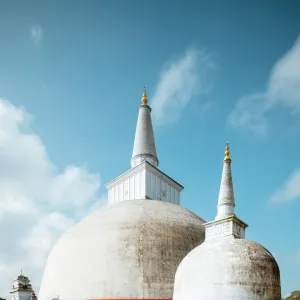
[270,169,300,203]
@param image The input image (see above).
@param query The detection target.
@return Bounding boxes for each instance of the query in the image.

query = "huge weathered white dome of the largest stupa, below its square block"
[38,200,204,300]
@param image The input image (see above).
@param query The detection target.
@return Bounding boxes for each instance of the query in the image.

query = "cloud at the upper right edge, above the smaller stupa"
[228,38,300,135]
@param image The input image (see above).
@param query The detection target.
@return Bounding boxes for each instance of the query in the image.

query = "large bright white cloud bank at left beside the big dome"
[0,99,104,299]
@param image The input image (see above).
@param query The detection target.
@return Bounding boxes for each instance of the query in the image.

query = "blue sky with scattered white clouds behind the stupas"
[0,0,300,297]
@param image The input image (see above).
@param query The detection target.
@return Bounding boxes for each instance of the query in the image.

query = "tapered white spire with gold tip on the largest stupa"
[131,89,158,168]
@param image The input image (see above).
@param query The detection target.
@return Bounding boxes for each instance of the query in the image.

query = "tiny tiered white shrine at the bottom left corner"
[10,271,37,300]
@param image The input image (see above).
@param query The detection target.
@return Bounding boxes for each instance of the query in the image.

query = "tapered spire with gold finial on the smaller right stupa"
[216,142,235,220]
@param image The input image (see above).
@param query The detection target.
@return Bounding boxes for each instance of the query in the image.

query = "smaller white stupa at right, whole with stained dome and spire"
[173,143,281,300]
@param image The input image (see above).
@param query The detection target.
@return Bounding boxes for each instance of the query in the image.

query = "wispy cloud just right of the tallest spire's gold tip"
[151,49,216,124]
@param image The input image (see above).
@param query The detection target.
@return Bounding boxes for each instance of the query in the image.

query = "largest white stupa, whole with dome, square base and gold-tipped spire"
[38,92,205,300]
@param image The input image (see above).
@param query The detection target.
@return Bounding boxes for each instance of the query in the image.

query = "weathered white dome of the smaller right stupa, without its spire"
[173,237,281,300]
